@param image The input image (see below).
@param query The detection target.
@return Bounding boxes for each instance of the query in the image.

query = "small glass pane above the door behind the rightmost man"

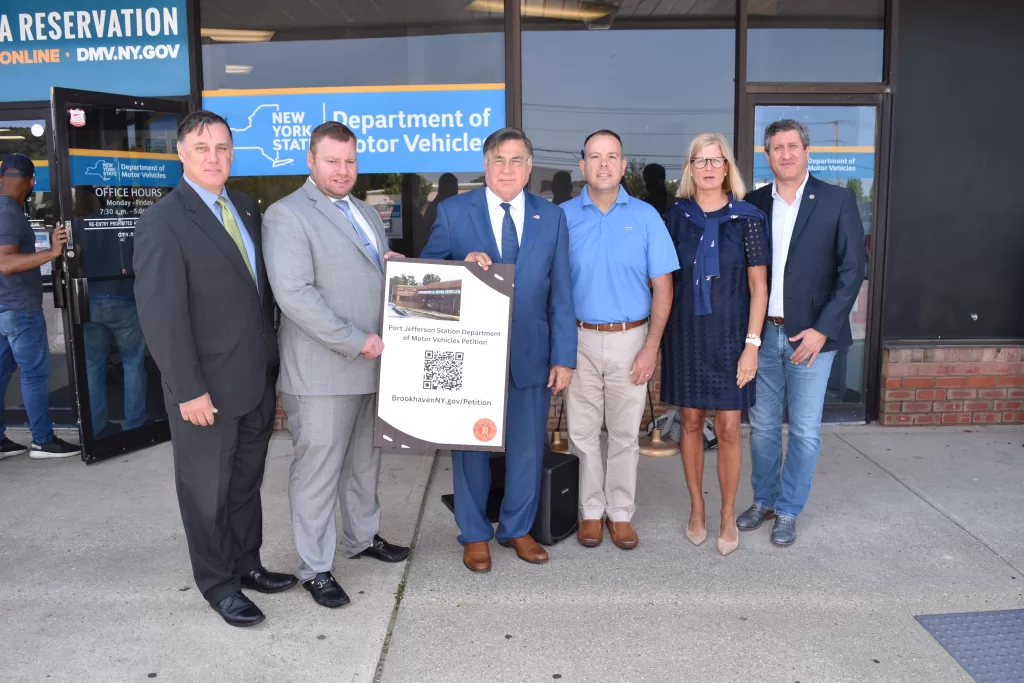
[746,0,885,83]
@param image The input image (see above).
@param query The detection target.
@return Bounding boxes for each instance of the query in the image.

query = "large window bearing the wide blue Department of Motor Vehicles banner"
[200,0,506,256]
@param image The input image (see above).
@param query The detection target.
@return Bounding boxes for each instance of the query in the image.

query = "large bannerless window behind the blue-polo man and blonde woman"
[522,0,735,211]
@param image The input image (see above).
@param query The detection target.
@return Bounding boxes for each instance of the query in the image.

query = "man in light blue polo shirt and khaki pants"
[562,130,679,550]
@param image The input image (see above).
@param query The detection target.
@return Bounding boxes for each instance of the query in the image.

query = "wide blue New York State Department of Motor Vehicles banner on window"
[203,84,505,176]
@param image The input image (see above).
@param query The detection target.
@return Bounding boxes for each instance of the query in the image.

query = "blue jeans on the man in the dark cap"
[0,310,53,443]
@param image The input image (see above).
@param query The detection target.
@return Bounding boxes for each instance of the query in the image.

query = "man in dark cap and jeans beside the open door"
[0,154,81,459]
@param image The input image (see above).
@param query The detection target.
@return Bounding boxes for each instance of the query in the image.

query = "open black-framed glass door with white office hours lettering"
[51,88,187,463]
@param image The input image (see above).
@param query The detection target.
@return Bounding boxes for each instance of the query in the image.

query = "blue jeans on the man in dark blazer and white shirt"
[749,323,836,516]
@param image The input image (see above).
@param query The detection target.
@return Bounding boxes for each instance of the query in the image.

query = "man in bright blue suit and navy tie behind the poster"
[420,128,577,571]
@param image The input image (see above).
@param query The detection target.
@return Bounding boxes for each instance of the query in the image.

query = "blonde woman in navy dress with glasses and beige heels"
[662,133,771,555]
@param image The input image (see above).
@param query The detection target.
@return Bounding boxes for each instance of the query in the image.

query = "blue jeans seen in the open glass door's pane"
[82,299,146,435]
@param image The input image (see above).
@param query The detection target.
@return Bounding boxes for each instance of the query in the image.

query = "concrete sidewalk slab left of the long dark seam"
[0,435,434,683]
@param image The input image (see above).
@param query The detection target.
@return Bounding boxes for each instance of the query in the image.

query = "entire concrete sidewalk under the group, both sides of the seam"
[0,427,1024,683]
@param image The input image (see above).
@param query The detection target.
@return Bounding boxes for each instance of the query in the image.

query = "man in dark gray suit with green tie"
[134,112,297,626]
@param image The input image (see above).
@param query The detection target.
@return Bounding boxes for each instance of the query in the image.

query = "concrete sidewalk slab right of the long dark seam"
[382,427,1024,683]
